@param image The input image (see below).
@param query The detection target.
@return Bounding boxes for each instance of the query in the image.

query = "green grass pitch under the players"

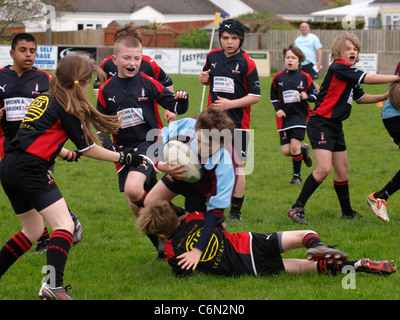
[0,75,400,300]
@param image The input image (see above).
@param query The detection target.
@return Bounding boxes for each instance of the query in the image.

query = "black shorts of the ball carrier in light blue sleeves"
[161,174,207,212]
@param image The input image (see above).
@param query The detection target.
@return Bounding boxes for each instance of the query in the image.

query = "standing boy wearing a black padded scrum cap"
[199,19,261,220]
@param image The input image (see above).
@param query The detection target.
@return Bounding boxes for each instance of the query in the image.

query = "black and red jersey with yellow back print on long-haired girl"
[10,94,90,166]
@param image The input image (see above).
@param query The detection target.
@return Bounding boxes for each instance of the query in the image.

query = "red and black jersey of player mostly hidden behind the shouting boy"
[93,55,174,89]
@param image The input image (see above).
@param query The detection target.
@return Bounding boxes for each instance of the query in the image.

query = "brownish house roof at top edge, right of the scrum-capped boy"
[243,0,329,15]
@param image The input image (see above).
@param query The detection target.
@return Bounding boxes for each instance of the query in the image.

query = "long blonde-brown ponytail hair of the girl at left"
[50,53,121,144]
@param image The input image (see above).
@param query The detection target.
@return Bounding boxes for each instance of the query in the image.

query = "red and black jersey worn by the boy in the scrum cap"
[203,48,261,129]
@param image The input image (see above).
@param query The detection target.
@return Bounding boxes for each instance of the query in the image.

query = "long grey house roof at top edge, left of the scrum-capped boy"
[71,0,224,15]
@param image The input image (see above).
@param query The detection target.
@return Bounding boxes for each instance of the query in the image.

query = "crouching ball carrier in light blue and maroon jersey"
[145,105,237,265]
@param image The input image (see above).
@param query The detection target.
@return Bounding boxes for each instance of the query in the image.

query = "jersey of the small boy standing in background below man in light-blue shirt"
[271,69,317,131]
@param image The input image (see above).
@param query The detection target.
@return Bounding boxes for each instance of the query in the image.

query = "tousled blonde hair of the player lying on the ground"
[136,200,178,235]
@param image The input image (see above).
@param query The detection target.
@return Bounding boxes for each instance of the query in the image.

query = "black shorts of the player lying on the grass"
[251,232,285,275]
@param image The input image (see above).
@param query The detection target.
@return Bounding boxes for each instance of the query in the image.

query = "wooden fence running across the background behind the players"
[28,29,400,74]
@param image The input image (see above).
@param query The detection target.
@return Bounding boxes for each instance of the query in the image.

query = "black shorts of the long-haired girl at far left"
[0,151,63,214]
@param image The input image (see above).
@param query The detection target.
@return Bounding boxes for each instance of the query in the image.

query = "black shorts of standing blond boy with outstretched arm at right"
[307,115,346,152]
